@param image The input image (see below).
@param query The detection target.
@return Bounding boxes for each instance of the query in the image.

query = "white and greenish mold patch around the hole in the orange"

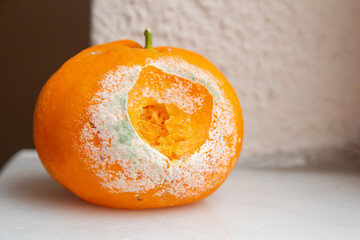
[81,58,241,199]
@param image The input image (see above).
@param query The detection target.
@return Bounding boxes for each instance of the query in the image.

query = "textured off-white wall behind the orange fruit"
[91,0,360,165]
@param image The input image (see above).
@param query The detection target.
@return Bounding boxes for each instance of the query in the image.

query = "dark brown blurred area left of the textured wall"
[0,0,90,168]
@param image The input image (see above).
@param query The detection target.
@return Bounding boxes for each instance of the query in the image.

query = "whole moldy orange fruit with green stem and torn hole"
[33,29,243,209]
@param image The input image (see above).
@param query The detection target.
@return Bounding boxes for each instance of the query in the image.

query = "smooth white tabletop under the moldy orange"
[0,150,360,240]
